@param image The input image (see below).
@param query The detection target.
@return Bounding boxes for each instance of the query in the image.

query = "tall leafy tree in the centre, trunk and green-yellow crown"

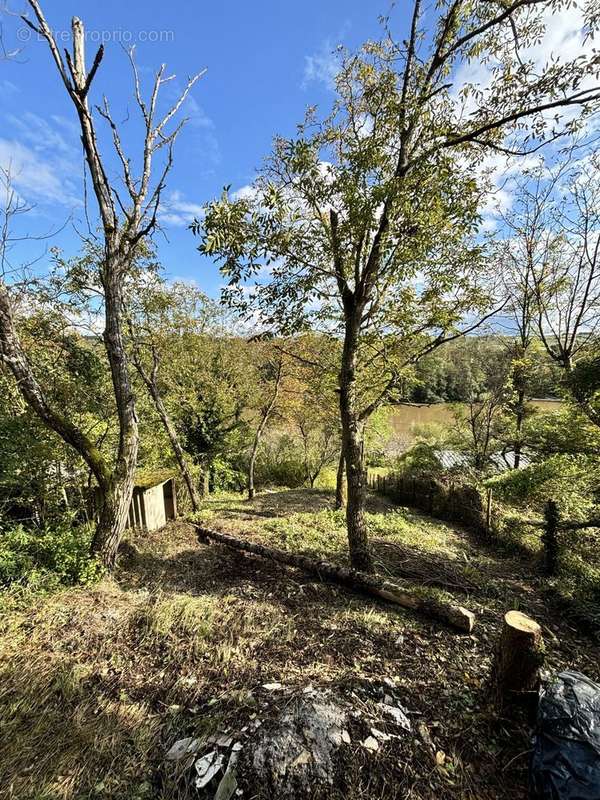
[193,0,600,569]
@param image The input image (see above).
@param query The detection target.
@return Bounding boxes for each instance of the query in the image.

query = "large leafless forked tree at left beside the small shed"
[0,6,200,569]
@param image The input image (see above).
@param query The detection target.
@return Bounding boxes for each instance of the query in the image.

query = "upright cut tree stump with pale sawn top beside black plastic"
[491,611,544,709]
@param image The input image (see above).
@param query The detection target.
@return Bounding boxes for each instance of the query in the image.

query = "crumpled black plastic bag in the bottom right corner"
[530,672,600,800]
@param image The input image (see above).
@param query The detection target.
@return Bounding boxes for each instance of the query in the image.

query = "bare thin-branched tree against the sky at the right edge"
[506,147,600,425]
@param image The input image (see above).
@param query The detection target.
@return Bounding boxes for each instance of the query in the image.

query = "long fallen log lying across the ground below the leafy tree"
[192,523,475,633]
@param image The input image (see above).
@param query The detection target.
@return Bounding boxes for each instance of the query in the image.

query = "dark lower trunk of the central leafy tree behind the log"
[340,313,373,572]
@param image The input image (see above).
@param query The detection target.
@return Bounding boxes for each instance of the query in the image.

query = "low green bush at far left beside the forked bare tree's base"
[0,521,102,590]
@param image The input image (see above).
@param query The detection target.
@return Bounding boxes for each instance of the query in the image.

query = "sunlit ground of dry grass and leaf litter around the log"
[0,490,600,800]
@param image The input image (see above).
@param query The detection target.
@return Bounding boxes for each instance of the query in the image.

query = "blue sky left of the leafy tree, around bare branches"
[0,0,404,296]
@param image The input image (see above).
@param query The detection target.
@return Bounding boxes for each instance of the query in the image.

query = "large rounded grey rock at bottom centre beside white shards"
[240,690,349,800]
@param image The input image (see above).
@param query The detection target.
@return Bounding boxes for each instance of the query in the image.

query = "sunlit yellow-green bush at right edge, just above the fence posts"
[487,454,600,519]
